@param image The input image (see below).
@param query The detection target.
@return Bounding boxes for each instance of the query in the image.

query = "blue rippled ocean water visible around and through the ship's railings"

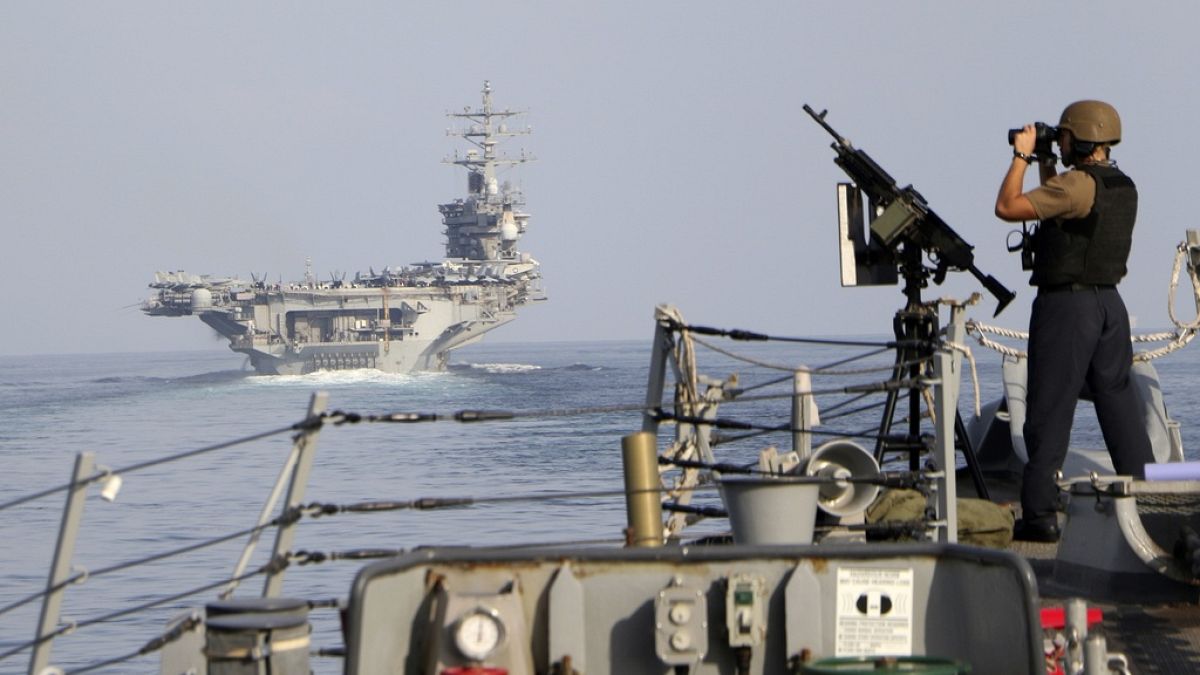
[0,338,1200,673]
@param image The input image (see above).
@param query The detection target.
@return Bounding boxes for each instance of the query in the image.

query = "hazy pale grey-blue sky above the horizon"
[0,0,1200,358]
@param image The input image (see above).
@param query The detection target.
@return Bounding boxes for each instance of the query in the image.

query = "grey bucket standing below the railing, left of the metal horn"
[721,477,820,544]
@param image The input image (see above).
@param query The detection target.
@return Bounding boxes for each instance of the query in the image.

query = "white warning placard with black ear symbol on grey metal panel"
[835,567,913,656]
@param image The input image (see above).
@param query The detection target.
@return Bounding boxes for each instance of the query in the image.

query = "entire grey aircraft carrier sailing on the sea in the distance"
[142,82,545,375]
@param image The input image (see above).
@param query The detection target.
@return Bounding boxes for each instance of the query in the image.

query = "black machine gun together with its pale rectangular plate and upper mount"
[804,103,1016,315]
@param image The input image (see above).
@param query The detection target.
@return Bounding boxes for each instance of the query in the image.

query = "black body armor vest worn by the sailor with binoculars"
[1030,165,1138,287]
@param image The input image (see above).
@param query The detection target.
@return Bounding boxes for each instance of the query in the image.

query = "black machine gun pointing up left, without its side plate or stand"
[804,103,1016,315]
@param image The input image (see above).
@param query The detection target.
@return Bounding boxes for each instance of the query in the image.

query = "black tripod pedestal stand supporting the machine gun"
[875,247,990,500]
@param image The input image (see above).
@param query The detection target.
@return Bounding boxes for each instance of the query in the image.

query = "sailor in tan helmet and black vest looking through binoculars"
[996,101,1154,542]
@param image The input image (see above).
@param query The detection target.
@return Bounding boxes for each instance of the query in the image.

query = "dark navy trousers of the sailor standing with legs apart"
[1021,286,1154,522]
